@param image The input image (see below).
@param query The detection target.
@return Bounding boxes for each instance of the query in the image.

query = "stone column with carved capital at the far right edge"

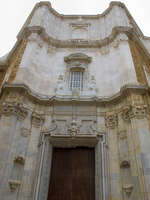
[127,105,150,200]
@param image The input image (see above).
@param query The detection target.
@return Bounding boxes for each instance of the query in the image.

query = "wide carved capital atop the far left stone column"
[2,102,28,120]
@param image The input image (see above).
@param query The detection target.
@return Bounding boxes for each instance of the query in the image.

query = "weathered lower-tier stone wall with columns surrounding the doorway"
[0,89,150,200]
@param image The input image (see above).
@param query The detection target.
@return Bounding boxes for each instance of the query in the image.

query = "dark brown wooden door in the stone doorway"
[48,147,95,200]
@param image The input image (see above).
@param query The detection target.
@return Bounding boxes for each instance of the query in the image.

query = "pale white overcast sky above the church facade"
[0,0,150,57]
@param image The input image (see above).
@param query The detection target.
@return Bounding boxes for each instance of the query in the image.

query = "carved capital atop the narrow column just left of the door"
[31,112,45,128]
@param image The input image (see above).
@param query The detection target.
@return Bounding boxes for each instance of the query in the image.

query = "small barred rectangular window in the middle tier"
[70,71,83,91]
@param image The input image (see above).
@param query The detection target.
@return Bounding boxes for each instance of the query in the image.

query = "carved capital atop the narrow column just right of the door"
[105,114,118,129]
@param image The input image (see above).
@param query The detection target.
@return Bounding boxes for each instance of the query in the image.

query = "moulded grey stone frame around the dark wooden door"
[33,133,109,200]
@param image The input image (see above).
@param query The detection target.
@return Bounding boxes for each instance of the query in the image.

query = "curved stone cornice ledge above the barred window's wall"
[19,26,134,48]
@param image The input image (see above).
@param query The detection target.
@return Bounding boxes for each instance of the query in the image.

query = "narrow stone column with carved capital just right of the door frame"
[105,113,122,200]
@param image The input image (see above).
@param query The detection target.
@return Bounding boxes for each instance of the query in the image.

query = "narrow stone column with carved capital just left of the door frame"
[18,112,44,200]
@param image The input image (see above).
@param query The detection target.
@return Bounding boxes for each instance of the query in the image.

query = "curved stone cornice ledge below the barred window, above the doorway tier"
[2,83,149,104]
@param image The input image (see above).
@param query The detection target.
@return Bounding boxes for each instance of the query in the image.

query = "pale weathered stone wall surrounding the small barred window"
[7,34,138,97]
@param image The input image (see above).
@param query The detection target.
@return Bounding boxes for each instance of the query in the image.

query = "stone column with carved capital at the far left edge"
[0,102,28,200]
